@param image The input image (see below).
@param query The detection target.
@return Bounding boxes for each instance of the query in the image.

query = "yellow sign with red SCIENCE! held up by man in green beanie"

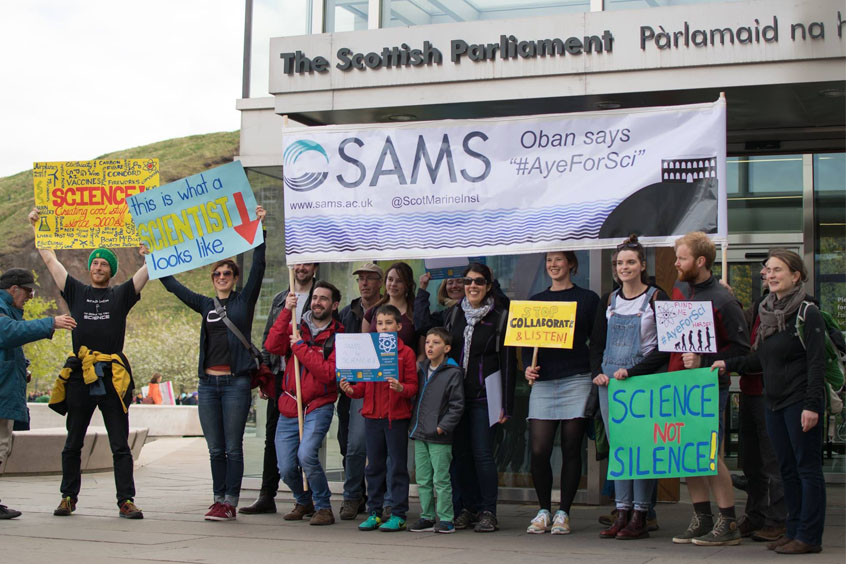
[32,159,159,249]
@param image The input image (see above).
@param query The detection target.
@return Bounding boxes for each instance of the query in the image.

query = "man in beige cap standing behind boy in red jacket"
[337,262,390,521]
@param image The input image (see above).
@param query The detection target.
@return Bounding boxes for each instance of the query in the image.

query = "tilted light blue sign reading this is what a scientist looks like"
[127,161,264,279]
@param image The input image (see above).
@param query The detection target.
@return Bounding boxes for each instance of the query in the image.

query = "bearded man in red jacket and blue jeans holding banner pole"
[264,281,344,525]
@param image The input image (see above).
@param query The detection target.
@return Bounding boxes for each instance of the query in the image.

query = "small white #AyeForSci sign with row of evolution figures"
[655,301,717,353]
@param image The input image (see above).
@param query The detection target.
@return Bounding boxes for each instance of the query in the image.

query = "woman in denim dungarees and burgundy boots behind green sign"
[590,235,670,540]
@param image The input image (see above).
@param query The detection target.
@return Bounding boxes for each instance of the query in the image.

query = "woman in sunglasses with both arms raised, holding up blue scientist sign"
[161,206,267,521]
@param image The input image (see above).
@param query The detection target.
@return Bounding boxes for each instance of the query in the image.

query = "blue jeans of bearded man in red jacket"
[276,403,335,509]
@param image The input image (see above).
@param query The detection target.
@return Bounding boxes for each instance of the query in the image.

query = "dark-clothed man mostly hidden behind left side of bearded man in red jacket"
[238,263,317,515]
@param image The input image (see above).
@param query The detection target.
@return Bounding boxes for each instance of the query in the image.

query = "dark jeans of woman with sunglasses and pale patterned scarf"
[452,401,499,515]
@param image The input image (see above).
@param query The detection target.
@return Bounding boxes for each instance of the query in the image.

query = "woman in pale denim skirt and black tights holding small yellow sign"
[523,251,599,535]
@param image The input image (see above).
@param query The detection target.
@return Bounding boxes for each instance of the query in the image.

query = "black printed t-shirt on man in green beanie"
[62,275,141,354]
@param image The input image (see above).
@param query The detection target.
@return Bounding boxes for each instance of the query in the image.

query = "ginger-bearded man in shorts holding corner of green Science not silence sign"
[669,231,749,546]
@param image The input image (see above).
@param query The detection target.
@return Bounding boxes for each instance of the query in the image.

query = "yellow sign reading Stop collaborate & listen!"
[505,300,577,349]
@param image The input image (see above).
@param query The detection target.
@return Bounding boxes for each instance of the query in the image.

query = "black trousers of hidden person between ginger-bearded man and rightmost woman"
[740,393,787,529]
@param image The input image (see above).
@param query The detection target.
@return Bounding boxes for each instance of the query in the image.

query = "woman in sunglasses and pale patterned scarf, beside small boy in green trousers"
[444,263,517,533]
